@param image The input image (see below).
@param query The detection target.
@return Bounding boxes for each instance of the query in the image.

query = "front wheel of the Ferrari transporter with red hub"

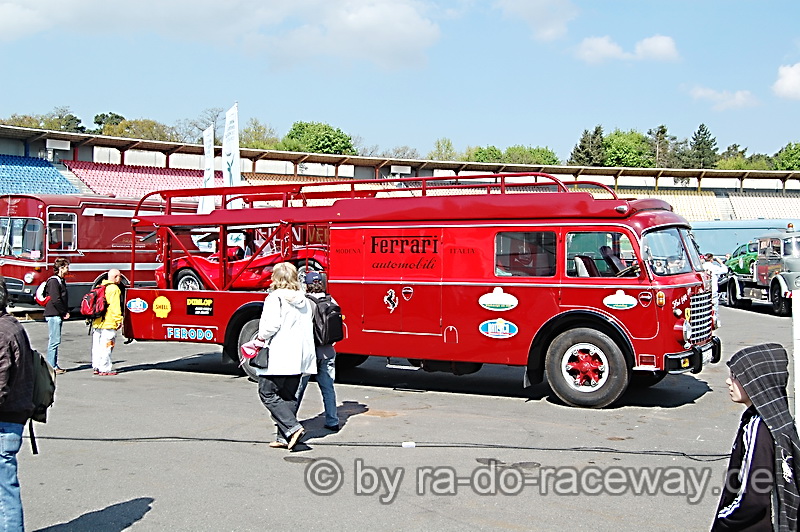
[545,328,630,408]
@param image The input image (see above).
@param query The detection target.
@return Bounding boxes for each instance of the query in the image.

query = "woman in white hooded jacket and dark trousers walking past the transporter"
[256,262,317,449]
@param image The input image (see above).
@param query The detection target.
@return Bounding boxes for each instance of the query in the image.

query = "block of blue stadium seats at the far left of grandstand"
[0,154,79,194]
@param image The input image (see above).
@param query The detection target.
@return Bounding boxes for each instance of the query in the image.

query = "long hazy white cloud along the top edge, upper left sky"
[0,0,440,69]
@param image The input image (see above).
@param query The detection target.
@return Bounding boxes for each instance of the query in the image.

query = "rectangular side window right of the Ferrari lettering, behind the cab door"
[495,231,556,277]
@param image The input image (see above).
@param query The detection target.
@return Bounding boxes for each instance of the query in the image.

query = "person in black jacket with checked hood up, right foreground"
[711,343,800,532]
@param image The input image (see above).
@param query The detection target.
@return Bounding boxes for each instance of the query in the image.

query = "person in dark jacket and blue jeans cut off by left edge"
[0,278,33,530]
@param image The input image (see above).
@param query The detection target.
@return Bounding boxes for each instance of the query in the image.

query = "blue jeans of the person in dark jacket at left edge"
[0,421,25,532]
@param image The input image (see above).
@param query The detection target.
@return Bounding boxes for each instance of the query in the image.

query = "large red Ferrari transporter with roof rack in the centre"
[125,173,721,407]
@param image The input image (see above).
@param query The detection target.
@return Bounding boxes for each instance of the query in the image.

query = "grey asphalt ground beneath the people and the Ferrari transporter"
[14,306,792,532]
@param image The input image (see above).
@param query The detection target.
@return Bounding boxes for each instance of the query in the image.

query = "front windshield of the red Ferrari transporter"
[642,227,700,275]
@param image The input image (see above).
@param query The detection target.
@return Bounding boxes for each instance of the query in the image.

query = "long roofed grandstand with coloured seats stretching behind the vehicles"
[0,125,800,228]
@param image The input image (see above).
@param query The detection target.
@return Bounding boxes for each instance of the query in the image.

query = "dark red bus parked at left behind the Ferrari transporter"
[0,194,196,308]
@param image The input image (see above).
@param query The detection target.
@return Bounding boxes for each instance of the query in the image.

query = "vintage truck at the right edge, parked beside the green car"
[725,224,800,316]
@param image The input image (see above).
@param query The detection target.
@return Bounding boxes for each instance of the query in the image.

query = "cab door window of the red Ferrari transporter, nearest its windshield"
[567,231,635,277]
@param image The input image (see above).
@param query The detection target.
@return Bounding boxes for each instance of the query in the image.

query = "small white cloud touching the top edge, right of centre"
[494,0,578,41]
